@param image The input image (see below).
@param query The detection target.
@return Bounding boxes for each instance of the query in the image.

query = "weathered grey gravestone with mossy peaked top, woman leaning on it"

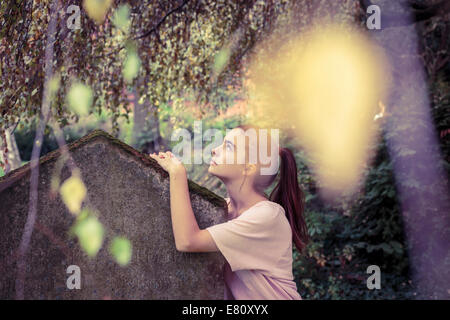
[0,130,227,299]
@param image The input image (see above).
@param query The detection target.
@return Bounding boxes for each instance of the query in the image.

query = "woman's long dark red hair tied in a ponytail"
[237,125,309,252]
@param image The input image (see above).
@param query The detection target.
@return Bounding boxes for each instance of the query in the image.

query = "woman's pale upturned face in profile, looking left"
[208,128,250,180]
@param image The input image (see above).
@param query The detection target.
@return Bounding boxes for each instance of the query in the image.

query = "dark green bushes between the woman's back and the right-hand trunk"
[293,132,414,299]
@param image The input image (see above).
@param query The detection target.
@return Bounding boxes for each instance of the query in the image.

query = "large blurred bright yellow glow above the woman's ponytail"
[249,26,389,197]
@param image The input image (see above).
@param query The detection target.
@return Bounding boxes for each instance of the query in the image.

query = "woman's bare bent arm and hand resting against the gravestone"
[150,151,218,252]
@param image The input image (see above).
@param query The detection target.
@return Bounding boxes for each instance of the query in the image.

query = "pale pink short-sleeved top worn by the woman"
[206,198,302,300]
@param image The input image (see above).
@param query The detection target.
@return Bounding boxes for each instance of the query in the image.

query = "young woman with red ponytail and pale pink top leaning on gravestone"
[150,125,308,300]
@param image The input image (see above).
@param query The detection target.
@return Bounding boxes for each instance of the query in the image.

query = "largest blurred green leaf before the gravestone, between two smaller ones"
[73,209,105,257]
